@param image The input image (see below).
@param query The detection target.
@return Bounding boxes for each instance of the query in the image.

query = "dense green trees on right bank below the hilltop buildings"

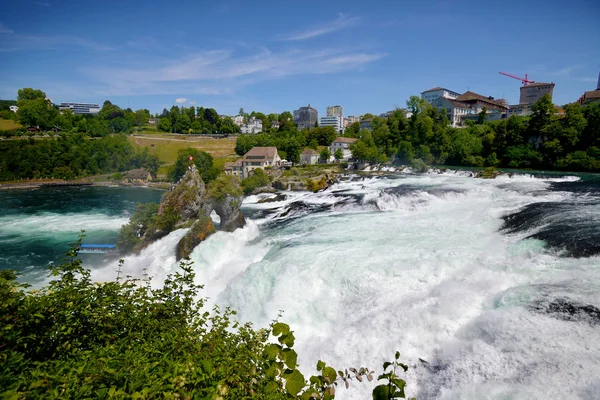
[345,95,600,171]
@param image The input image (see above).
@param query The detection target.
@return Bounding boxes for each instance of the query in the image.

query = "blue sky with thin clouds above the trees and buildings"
[0,0,600,115]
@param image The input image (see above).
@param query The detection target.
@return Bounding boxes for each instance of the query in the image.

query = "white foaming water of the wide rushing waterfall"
[95,173,600,399]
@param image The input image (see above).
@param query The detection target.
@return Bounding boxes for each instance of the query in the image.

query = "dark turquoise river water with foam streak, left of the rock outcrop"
[0,187,164,280]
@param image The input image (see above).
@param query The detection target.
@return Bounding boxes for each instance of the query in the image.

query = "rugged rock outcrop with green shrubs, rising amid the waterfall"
[136,170,246,260]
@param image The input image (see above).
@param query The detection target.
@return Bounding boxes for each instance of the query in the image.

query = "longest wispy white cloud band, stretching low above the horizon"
[80,44,386,95]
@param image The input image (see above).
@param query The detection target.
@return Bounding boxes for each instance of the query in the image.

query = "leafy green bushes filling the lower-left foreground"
[0,233,418,400]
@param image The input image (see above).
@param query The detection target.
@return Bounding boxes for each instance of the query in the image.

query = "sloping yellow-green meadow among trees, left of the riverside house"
[129,133,237,166]
